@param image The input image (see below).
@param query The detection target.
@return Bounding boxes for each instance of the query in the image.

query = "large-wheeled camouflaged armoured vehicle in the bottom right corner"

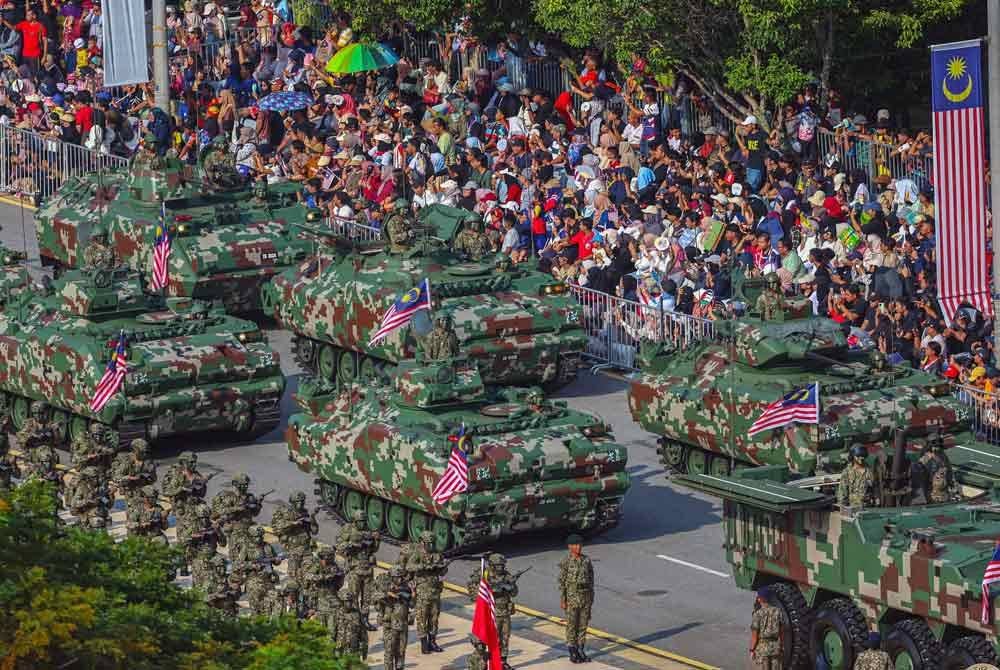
[674,456,1000,670]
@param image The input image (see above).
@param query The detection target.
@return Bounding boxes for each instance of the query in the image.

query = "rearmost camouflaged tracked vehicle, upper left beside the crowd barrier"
[35,150,320,313]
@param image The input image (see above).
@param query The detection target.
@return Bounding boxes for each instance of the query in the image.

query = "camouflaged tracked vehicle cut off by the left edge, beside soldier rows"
[0,269,285,442]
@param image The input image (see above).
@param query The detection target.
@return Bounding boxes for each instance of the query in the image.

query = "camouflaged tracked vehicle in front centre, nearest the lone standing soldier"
[286,361,629,551]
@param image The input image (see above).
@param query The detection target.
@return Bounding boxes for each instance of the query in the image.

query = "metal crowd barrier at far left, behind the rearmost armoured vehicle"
[0,126,128,198]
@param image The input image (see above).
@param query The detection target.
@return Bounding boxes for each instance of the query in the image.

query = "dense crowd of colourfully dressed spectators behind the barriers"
[0,0,984,396]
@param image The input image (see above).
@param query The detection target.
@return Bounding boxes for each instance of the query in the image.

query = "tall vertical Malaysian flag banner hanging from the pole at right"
[931,40,993,320]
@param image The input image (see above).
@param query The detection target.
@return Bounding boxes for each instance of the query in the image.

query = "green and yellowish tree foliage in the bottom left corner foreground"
[0,483,365,670]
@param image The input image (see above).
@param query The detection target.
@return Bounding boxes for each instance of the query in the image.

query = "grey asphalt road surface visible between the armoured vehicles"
[0,205,752,668]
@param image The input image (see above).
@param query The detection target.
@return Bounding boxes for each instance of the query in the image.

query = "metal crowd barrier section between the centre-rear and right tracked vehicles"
[569,286,716,370]
